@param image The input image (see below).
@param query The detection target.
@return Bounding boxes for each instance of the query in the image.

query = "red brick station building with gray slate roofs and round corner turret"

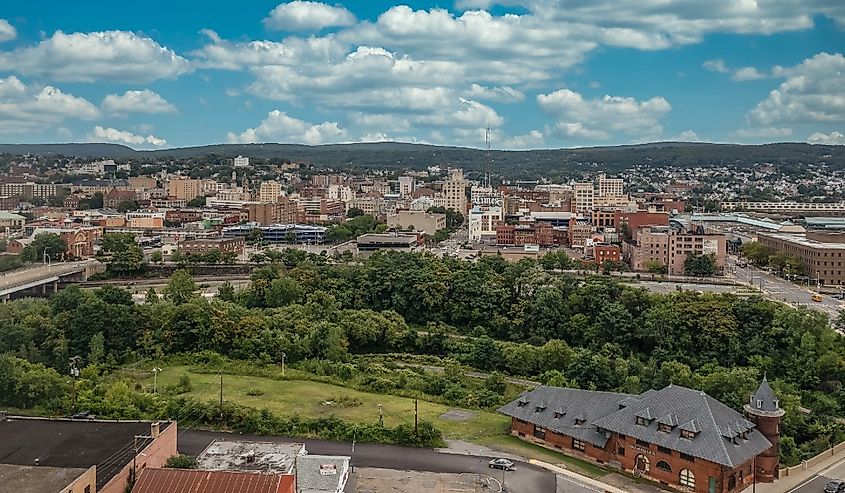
[499,380,783,493]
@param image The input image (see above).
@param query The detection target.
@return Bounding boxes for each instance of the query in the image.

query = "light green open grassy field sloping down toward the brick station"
[134,366,607,477]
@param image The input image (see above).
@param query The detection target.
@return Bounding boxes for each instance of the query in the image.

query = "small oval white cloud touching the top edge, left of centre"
[264,0,356,31]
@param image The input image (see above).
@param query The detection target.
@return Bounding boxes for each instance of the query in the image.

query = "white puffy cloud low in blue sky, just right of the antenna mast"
[537,89,672,140]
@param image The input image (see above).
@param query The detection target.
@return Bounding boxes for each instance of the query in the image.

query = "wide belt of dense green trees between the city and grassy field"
[0,250,845,462]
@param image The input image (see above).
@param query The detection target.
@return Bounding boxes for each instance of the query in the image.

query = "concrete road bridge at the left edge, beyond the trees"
[0,259,105,303]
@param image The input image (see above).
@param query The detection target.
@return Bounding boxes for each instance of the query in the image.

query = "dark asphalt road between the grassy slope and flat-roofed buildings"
[178,430,556,493]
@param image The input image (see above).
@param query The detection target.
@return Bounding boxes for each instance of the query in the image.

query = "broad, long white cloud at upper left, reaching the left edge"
[0,31,192,83]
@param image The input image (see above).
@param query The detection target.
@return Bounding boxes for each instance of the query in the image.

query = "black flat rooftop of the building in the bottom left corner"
[0,416,172,488]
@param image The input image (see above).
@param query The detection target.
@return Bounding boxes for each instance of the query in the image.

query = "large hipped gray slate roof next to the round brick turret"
[595,385,772,467]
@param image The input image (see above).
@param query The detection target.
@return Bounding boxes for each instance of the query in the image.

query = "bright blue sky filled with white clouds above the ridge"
[0,0,845,149]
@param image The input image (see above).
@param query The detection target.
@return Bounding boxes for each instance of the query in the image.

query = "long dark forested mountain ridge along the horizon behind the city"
[0,142,845,177]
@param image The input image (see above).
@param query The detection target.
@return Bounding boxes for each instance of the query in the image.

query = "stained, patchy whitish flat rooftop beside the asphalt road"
[197,440,306,474]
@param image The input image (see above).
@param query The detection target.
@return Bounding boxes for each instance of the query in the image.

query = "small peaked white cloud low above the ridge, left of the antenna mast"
[226,110,347,145]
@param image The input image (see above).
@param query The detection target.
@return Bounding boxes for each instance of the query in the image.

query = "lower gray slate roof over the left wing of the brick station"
[499,386,636,447]
